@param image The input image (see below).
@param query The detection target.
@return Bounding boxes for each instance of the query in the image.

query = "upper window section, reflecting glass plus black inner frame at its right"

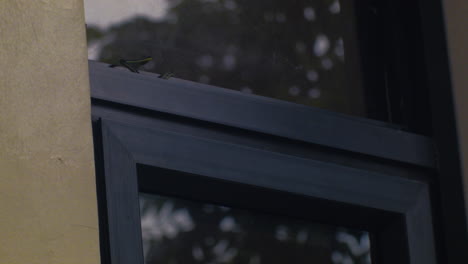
[86,0,430,133]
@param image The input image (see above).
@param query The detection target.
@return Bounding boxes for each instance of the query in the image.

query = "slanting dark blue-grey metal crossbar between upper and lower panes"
[89,61,436,168]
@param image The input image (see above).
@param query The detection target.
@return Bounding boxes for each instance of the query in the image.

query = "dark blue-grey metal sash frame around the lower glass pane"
[91,118,437,264]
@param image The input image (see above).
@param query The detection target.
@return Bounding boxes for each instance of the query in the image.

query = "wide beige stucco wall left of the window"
[0,0,100,264]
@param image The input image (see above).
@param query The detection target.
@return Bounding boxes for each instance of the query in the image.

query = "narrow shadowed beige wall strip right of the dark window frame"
[444,0,468,225]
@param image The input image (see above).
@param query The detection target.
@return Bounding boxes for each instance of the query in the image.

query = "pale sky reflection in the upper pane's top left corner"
[84,0,168,29]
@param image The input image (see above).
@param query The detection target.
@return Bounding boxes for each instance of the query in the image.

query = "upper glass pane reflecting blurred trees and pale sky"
[85,0,375,117]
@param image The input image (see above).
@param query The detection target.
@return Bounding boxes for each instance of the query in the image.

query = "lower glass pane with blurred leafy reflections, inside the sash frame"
[140,193,371,264]
